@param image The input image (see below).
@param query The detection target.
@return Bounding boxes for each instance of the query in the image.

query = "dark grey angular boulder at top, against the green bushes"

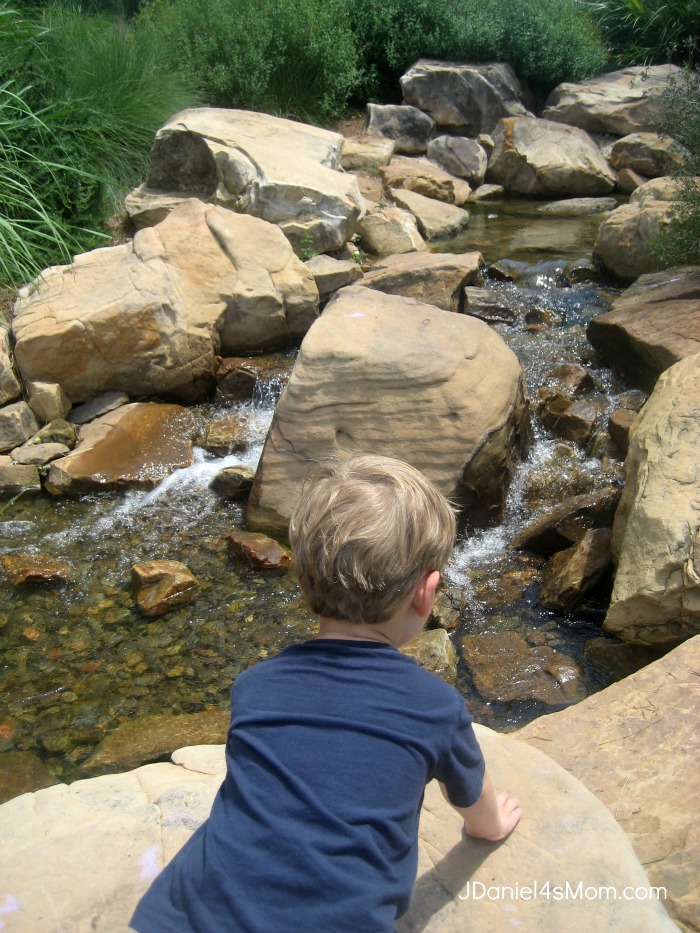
[401,58,528,136]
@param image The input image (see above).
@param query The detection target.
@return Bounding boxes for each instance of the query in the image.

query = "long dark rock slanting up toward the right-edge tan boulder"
[509,488,620,554]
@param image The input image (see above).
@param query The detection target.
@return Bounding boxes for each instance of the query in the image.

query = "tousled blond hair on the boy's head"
[289,454,456,623]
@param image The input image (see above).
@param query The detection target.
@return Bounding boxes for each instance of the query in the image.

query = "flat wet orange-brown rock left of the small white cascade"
[45,402,194,495]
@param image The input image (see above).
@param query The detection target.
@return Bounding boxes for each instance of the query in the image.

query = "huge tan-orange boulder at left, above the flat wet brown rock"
[13,199,318,403]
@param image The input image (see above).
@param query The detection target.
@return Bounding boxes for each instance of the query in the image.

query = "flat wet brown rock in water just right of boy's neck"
[462,632,586,706]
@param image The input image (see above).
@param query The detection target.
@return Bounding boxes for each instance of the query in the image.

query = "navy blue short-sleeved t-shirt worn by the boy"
[131,639,484,933]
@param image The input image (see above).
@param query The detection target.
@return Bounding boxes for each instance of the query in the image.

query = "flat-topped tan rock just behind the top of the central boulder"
[361,253,484,311]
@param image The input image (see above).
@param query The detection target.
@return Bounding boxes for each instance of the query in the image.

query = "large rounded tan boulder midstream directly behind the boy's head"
[246,286,528,532]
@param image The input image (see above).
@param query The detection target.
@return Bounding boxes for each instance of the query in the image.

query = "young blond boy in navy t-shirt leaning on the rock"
[131,455,521,933]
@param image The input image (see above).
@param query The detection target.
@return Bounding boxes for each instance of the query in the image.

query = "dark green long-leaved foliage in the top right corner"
[584,0,700,67]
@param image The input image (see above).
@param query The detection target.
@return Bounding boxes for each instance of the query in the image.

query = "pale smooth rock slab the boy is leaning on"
[0,717,676,933]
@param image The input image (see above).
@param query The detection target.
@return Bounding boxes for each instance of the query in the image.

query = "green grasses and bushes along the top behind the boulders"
[0,0,700,285]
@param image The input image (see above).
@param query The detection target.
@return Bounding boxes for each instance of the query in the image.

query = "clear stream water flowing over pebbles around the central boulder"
[0,205,644,792]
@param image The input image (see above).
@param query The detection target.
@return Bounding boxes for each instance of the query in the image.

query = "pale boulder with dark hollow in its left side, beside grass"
[126,107,364,253]
